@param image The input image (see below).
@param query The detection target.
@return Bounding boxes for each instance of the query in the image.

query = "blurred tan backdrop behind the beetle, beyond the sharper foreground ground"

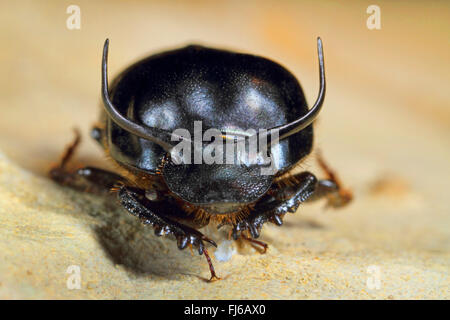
[0,0,450,300]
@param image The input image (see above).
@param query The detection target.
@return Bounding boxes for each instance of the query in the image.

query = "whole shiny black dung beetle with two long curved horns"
[50,38,352,280]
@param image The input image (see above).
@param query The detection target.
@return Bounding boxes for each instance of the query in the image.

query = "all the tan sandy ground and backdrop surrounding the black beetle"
[0,1,450,299]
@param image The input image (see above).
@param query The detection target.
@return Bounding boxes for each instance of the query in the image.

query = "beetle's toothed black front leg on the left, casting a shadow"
[117,185,219,281]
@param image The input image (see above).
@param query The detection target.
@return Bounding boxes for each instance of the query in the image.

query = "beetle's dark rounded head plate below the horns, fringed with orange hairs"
[161,140,274,214]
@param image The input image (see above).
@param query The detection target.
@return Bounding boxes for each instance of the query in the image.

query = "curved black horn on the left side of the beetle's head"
[102,39,185,152]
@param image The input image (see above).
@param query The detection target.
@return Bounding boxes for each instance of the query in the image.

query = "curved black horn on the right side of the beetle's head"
[267,37,326,140]
